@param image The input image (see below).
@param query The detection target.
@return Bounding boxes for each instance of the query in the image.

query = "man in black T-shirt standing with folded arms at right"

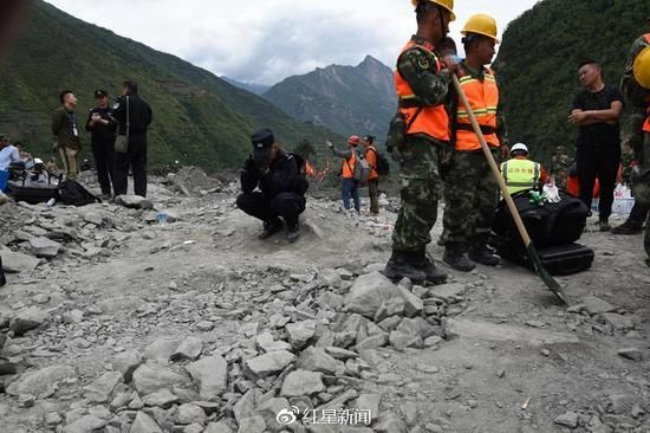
[569,60,623,231]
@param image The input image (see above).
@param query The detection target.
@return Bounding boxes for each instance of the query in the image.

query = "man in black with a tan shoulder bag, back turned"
[113,81,152,197]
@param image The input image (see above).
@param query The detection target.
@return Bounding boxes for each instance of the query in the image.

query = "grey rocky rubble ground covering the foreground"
[0,169,650,433]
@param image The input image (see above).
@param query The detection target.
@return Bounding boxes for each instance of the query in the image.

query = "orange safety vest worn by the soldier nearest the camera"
[394,41,449,141]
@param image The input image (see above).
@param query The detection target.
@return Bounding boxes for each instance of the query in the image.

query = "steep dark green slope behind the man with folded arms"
[494,0,650,163]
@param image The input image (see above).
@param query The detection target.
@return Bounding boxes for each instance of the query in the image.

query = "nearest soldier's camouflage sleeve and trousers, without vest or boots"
[393,36,451,252]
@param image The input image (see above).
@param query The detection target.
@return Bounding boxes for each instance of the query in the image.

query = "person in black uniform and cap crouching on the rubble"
[237,129,309,243]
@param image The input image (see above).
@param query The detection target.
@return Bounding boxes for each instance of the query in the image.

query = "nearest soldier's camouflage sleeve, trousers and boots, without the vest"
[384,36,451,284]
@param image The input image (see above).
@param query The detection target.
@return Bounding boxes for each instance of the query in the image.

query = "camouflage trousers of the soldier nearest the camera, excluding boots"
[393,137,441,252]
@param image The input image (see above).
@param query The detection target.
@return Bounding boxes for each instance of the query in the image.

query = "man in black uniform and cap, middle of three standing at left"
[86,90,117,200]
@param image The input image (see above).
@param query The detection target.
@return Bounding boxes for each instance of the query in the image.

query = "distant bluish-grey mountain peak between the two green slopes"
[263,56,397,141]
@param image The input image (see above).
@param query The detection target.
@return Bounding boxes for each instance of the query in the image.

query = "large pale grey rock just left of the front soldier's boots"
[343,272,400,319]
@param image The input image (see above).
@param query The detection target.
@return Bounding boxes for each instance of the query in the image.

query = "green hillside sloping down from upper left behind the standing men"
[0,0,341,172]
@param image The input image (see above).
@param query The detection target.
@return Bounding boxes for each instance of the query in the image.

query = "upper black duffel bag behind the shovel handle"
[492,191,589,249]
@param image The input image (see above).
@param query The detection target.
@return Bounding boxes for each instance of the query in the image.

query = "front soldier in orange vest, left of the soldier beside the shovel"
[384,0,456,284]
